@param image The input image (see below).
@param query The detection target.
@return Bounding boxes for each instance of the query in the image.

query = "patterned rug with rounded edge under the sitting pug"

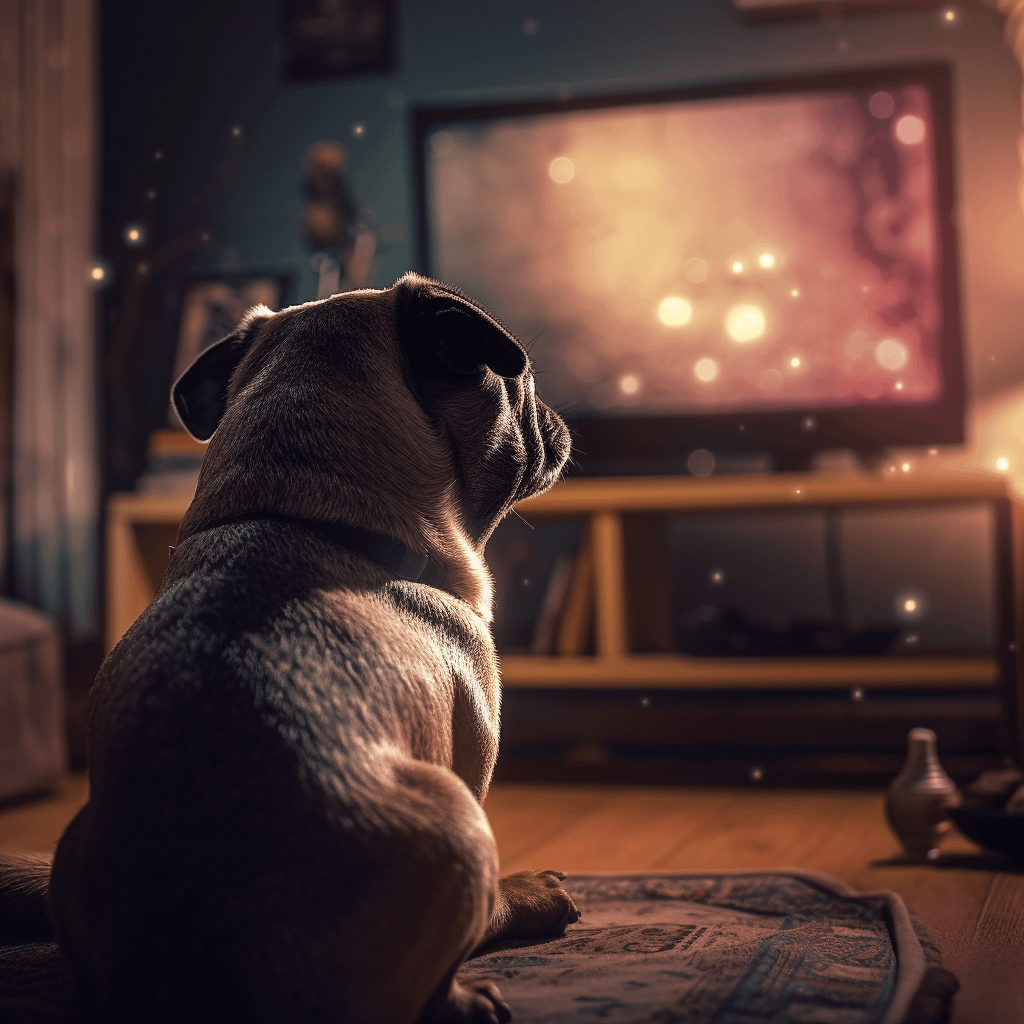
[0,871,957,1024]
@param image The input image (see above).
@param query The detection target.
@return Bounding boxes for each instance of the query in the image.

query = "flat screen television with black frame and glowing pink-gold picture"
[413,63,965,473]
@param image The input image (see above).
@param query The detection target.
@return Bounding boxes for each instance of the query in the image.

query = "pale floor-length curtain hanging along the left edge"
[0,0,99,638]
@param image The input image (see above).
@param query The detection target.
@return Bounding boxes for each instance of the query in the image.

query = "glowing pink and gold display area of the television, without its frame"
[428,86,942,416]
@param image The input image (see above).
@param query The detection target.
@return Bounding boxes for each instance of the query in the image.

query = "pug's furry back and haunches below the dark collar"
[53,522,497,1021]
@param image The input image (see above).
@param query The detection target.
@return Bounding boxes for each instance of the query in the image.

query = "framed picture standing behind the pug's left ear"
[167,271,291,427]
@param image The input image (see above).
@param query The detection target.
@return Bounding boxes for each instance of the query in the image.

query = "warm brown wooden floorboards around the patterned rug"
[0,778,1024,1024]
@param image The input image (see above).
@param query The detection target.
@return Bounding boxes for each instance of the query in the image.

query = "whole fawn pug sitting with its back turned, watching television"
[0,274,579,1024]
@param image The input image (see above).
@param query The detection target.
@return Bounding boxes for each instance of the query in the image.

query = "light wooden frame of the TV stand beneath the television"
[106,473,1024,714]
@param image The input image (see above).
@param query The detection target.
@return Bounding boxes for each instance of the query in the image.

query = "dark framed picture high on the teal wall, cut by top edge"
[279,0,397,82]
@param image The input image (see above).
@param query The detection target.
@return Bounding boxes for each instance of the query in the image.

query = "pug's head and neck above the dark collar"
[172,273,569,606]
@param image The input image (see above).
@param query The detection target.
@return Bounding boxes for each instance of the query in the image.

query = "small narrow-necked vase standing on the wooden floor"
[886,729,957,860]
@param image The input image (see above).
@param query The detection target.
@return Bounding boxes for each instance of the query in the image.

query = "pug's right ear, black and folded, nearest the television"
[395,273,528,378]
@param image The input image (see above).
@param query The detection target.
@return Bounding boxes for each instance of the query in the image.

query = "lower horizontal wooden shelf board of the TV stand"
[502,654,999,690]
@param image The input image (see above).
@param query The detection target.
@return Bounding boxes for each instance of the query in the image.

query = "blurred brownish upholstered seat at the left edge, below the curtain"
[0,598,68,800]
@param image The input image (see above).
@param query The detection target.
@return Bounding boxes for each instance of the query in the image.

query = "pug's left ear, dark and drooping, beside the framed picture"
[171,306,270,441]
